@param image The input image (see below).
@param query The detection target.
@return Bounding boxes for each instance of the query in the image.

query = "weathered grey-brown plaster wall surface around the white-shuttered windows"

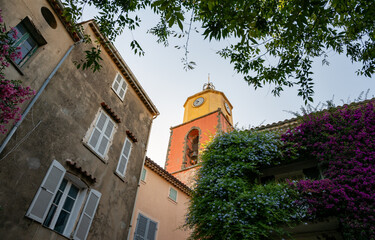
[0,0,153,239]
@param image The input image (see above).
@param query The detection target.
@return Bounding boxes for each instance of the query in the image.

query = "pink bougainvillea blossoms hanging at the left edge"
[0,10,34,134]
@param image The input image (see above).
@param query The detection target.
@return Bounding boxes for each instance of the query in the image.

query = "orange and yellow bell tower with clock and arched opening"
[165,82,233,187]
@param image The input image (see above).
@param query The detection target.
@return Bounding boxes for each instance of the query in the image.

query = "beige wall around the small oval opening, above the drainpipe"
[0,0,73,142]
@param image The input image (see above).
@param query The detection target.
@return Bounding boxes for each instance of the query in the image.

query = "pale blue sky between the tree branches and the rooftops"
[84,8,375,166]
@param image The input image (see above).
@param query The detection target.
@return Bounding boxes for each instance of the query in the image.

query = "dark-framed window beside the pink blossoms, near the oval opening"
[9,17,47,66]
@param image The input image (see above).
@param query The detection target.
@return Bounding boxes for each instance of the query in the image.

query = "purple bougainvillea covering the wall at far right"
[282,101,375,240]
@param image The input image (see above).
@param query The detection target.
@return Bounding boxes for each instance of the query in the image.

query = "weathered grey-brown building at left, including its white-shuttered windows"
[0,0,159,239]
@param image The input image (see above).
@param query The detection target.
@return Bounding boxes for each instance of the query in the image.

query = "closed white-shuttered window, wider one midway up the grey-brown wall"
[87,110,115,158]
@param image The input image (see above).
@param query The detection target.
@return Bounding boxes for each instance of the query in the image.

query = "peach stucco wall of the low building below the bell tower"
[129,166,194,240]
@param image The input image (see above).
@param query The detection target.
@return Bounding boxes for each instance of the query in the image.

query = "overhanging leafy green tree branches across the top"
[66,0,375,102]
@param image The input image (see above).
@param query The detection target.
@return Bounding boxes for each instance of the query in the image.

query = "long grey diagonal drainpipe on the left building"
[0,39,83,153]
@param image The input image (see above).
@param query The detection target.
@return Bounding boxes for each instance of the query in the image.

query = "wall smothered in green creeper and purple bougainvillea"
[187,101,375,240]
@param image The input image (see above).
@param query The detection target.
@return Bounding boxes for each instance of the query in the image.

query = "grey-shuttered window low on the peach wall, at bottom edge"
[134,214,158,240]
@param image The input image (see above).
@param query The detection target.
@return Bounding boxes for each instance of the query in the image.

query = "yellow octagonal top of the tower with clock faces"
[183,82,233,125]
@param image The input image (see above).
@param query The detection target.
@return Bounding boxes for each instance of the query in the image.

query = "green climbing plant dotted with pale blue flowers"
[187,130,305,239]
